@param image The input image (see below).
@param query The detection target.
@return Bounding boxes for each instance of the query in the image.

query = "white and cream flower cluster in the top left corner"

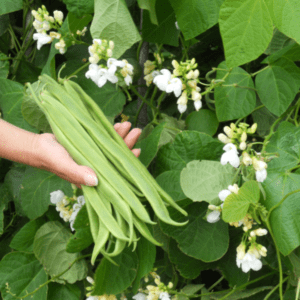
[31,5,66,54]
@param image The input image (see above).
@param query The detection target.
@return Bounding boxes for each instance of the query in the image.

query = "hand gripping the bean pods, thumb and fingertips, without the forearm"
[37,122,142,188]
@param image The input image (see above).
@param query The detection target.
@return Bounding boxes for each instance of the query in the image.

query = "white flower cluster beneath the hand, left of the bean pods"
[50,190,85,231]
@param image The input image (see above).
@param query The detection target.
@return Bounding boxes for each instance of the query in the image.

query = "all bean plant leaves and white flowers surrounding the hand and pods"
[0,0,300,300]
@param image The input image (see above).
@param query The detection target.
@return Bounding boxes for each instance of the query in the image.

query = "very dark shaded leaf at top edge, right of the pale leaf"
[142,0,179,47]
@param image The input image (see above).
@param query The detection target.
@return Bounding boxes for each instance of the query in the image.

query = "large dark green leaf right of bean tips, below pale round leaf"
[159,202,229,262]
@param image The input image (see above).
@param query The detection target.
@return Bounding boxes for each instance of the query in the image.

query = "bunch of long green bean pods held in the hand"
[27,74,187,264]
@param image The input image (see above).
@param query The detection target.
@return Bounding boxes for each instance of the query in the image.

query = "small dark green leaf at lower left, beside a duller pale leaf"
[9,218,45,252]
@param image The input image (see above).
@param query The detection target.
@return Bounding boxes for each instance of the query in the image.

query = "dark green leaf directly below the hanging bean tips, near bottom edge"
[93,247,138,295]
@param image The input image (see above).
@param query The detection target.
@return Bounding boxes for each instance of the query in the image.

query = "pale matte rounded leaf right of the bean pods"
[180,160,236,203]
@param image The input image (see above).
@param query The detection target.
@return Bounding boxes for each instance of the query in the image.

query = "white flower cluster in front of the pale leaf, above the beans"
[85,39,133,87]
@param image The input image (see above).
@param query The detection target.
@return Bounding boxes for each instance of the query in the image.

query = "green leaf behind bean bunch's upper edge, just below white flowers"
[74,75,126,117]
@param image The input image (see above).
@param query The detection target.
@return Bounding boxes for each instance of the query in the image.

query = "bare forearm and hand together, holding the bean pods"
[0,119,141,188]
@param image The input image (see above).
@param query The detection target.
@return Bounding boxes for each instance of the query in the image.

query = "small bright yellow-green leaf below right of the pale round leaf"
[222,180,260,223]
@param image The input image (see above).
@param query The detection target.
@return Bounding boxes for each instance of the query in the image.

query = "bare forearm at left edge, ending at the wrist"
[0,119,40,167]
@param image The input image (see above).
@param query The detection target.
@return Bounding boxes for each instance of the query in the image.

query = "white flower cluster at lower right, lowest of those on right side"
[236,228,268,273]
